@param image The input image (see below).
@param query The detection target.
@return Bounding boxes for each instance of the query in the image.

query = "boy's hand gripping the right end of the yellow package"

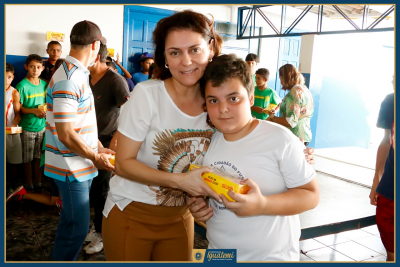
[220,179,266,216]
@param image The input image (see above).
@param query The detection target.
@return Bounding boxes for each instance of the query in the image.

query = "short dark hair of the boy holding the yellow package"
[200,54,254,129]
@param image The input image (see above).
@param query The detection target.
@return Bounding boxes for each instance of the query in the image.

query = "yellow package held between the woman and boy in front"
[189,164,250,202]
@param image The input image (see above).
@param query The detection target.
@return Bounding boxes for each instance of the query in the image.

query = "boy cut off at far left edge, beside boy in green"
[6,63,22,193]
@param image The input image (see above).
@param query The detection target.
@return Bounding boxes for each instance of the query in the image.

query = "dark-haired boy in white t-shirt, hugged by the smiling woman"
[188,54,319,261]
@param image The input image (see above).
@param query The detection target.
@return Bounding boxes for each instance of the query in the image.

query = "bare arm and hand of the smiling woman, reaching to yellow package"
[115,132,219,199]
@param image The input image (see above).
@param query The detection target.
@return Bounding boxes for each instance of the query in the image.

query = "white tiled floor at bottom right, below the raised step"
[300,225,386,262]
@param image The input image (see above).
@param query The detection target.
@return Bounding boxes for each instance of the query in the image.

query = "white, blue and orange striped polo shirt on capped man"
[44,56,98,182]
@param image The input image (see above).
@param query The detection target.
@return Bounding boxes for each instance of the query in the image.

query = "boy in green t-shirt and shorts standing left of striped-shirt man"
[16,54,47,191]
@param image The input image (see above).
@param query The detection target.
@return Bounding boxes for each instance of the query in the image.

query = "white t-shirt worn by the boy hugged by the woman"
[203,120,315,261]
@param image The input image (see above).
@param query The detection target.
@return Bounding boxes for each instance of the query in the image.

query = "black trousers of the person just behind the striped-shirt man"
[90,170,112,233]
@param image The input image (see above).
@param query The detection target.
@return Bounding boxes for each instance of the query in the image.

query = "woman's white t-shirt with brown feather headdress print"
[103,80,214,217]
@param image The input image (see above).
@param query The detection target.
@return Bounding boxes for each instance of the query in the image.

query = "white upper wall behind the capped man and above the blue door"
[6,5,237,57]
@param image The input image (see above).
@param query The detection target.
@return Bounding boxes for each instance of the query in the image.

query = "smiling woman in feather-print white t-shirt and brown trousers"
[103,10,222,261]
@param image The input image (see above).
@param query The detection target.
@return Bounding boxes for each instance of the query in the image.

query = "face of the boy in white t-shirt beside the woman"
[205,78,254,135]
